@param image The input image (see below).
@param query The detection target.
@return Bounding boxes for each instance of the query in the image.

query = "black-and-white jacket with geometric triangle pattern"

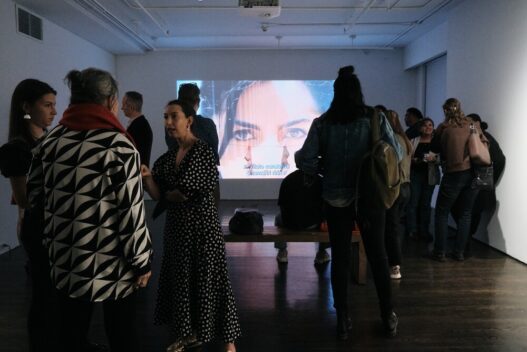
[28,125,152,302]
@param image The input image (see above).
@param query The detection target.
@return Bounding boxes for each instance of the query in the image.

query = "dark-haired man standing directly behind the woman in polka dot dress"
[165,83,220,165]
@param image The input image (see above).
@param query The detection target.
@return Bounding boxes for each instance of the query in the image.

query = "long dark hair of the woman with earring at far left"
[8,78,57,143]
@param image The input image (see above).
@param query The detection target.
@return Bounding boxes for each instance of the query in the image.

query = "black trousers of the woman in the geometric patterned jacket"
[57,292,140,352]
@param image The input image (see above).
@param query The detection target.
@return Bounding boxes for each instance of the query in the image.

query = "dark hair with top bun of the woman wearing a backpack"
[325,66,367,123]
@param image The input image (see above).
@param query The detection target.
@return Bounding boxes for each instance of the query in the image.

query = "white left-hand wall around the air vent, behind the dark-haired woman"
[0,0,115,253]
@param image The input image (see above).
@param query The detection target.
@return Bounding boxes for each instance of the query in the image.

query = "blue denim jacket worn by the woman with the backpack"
[295,109,403,207]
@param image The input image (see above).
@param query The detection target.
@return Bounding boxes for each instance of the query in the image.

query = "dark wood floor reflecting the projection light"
[0,201,527,352]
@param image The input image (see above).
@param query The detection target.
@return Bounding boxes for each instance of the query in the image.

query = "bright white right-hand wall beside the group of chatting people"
[404,0,527,263]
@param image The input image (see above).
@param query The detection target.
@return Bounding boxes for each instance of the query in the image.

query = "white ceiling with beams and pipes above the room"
[15,0,463,54]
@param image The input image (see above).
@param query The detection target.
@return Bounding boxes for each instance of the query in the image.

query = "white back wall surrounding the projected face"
[117,50,417,199]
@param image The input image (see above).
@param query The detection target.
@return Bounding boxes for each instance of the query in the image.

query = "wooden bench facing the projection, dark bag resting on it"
[222,226,368,285]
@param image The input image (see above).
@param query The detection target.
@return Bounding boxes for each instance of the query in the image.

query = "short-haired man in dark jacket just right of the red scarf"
[121,91,153,166]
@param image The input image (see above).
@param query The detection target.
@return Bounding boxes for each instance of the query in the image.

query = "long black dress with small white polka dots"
[152,140,240,343]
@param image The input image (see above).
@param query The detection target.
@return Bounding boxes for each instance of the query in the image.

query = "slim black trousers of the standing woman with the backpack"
[326,203,393,318]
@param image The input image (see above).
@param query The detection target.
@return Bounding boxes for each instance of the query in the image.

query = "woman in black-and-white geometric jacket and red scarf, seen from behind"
[28,68,152,351]
